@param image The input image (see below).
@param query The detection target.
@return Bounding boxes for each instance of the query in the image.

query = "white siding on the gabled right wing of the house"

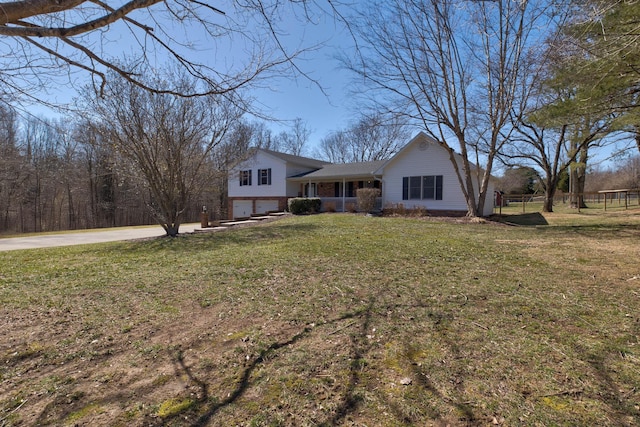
[382,141,467,211]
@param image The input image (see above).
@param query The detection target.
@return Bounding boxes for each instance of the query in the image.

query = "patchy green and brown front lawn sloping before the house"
[0,214,640,426]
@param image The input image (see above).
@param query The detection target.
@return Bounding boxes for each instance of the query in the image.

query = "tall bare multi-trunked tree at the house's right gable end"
[345,0,557,216]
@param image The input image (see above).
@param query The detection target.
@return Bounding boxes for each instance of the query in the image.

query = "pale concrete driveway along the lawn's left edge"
[0,223,200,251]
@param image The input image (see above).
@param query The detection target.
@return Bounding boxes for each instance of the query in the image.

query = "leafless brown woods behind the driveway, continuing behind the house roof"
[0,76,407,235]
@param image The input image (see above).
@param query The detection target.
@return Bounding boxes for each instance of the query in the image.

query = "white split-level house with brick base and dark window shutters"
[229,132,494,218]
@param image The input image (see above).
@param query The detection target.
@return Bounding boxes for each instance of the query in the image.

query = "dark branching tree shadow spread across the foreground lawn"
[22,287,478,427]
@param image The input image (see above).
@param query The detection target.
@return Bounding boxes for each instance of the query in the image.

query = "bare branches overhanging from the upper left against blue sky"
[0,0,344,101]
